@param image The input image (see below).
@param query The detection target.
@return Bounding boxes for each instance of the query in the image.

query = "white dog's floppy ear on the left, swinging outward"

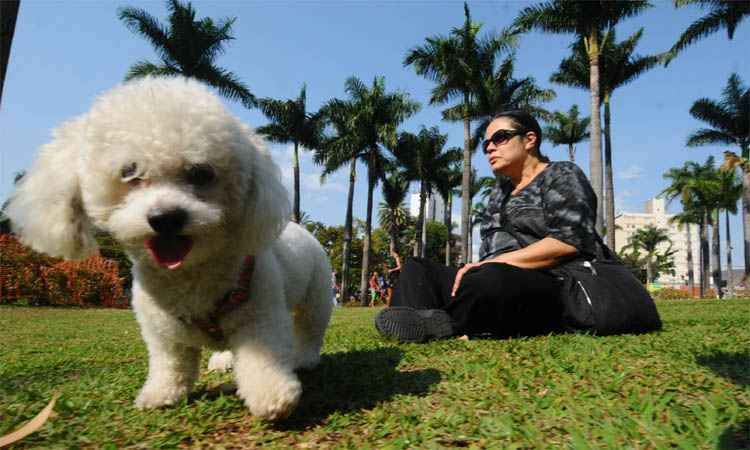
[5,118,96,259]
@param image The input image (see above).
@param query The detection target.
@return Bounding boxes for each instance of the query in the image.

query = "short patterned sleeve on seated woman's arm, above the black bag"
[542,162,597,255]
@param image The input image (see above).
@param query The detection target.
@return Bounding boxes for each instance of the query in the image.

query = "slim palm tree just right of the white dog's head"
[257,85,326,223]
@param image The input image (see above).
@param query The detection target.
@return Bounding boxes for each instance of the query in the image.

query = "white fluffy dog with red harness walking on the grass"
[6,78,332,420]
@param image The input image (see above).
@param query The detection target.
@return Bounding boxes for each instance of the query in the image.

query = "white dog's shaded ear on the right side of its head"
[243,127,292,253]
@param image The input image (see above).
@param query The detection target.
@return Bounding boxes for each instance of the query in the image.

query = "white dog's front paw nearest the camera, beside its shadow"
[238,377,302,420]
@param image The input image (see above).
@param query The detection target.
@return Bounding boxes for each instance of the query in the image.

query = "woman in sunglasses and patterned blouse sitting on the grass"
[375,111,601,342]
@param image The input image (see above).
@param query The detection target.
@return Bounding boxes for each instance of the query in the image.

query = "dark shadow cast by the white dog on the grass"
[191,347,441,430]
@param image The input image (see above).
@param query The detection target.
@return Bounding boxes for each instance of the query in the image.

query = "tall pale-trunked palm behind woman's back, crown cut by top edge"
[514,0,651,236]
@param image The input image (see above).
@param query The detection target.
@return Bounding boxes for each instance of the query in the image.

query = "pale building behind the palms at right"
[615,198,712,287]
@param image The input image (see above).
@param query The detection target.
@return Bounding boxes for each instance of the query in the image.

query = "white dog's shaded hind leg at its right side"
[294,260,333,369]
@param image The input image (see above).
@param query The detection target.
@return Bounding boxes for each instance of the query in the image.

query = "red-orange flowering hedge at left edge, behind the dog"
[0,234,128,308]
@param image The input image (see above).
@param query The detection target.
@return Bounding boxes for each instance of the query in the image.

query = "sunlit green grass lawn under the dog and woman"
[0,300,750,449]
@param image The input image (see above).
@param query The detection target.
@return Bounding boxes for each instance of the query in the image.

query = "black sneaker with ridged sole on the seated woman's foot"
[375,306,453,342]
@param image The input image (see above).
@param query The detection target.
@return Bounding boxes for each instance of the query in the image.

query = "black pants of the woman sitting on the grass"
[391,258,562,337]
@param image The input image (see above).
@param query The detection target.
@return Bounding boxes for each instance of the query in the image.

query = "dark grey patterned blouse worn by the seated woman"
[479,161,600,260]
